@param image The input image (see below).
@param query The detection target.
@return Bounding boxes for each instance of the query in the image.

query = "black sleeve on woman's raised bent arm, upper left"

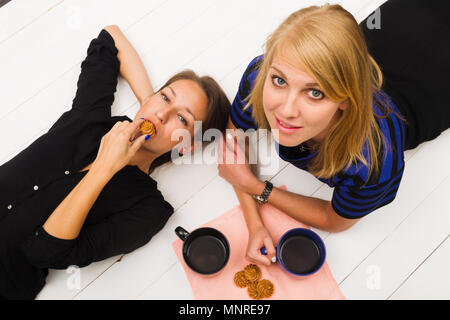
[72,29,120,115]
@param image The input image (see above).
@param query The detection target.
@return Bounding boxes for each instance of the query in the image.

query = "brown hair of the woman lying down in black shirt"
[148,70,231,174]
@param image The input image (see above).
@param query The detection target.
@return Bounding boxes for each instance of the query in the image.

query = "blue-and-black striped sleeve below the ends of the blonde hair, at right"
[331,170,403,219]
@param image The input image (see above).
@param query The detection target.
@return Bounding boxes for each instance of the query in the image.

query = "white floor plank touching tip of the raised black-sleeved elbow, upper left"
[0,0,166,120]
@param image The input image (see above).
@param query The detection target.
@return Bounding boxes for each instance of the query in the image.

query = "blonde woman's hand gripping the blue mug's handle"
[247,226,276,266]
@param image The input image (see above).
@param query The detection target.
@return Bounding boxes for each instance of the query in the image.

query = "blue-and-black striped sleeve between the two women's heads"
[230,55,263,131]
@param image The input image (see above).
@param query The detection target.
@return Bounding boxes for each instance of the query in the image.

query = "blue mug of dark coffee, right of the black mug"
[260,228,326,277]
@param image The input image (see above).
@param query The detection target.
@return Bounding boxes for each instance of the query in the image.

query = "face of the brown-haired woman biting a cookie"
[130,80,208,155]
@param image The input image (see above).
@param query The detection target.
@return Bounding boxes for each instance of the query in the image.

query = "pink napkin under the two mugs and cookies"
[172,186,345,300]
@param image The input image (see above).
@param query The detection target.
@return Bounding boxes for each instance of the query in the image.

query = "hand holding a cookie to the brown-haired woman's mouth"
[92,119,146,175]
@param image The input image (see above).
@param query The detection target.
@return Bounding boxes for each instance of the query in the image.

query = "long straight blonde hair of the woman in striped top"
[244,4,401,182]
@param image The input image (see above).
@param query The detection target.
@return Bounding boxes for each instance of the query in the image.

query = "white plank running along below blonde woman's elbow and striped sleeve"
[316,130,450,283]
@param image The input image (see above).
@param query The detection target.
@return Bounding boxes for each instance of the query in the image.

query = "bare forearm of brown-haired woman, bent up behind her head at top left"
[104,25,154,105]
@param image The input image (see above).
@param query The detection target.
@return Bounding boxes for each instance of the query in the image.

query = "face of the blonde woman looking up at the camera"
[263,56,347,147]
